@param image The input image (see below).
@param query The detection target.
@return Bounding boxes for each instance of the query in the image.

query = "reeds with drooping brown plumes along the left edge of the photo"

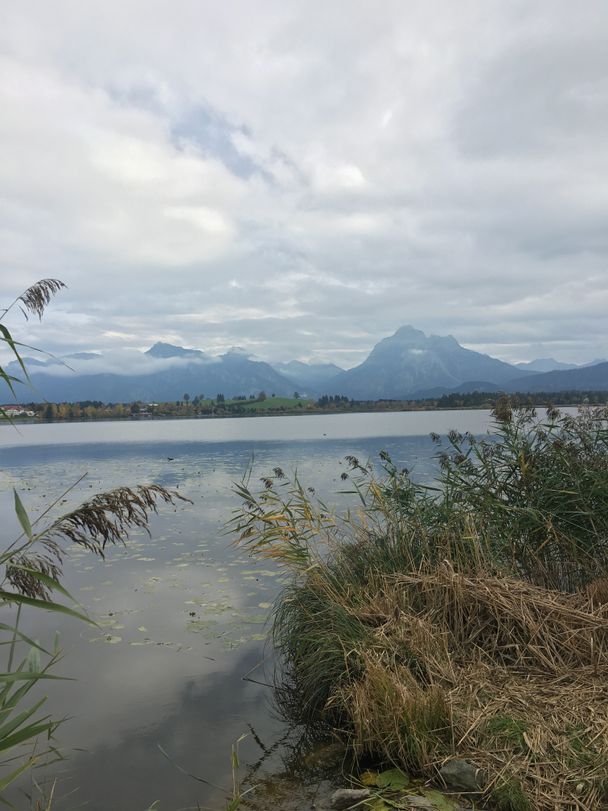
[0,279,187,800]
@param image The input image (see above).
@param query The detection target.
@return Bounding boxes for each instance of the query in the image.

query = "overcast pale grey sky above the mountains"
[0,0,608,367]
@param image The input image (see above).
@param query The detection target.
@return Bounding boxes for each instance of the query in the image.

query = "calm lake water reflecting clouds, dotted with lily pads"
[0,411,490,811]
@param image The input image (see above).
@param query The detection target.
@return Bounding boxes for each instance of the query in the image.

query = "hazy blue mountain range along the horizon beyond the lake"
[6,326,608,403]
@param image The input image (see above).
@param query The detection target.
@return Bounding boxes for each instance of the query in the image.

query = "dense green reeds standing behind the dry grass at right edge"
[440,398,608,591]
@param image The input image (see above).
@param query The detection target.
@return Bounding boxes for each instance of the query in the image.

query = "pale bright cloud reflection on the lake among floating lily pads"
[16,519,277,746]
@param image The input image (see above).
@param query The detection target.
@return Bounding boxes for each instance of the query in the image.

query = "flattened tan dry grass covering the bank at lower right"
[327,565,608,811]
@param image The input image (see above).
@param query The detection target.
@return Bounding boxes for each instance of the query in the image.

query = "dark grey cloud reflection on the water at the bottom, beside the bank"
[34,650,283,811]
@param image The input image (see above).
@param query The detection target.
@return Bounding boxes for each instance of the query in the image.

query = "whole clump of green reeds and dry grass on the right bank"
[233,400,608,811]
